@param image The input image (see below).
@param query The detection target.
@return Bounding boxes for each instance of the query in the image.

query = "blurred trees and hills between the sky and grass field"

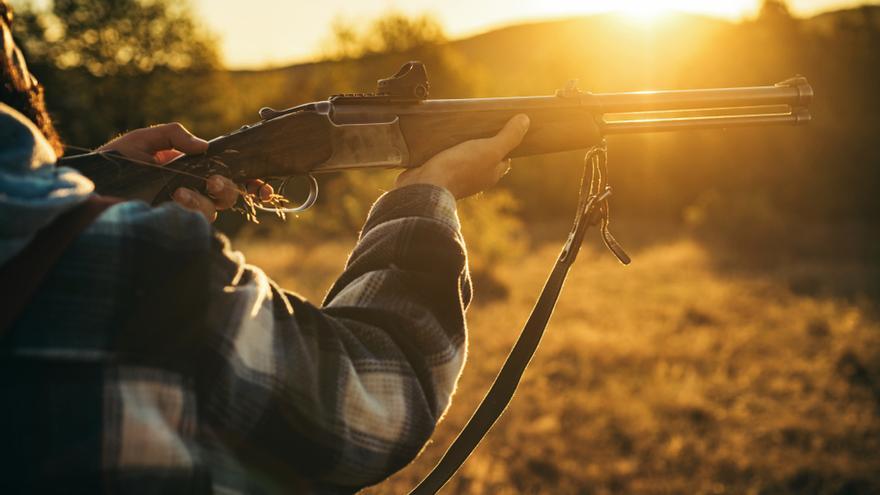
[8,0,880,259]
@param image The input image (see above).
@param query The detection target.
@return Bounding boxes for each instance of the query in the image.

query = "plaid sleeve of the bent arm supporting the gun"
[202,185,471,488]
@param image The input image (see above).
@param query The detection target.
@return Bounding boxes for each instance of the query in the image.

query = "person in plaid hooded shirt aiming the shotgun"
[0,0,528,494]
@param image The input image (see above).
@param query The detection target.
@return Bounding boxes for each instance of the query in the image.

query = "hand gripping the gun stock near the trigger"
[98,122,273,222]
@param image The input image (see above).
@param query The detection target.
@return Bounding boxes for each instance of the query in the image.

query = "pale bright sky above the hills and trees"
[192,0,863,69]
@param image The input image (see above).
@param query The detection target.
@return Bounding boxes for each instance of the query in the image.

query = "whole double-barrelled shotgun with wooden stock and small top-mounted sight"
[63,62,813,211]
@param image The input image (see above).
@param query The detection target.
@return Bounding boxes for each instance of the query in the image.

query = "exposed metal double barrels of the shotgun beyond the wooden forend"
[596,76,813,134]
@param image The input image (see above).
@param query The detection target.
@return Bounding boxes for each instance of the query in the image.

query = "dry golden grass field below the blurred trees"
[239,222,880,494]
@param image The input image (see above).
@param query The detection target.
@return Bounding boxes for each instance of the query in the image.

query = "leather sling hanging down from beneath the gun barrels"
[410,143,629,495]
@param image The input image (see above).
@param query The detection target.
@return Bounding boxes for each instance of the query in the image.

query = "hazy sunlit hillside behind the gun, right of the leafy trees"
[218,7,880,232]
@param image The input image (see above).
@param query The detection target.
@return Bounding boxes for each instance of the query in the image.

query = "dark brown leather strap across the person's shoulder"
[0,195,122,335]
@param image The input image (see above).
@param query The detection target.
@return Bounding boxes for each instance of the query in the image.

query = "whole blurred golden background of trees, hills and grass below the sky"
[13,0,880,494]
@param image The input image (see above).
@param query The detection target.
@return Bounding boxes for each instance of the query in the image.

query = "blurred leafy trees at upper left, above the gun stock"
[13,0,234,147]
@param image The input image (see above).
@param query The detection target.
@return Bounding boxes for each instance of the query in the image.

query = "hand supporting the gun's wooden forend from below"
[395,114,529,199]
